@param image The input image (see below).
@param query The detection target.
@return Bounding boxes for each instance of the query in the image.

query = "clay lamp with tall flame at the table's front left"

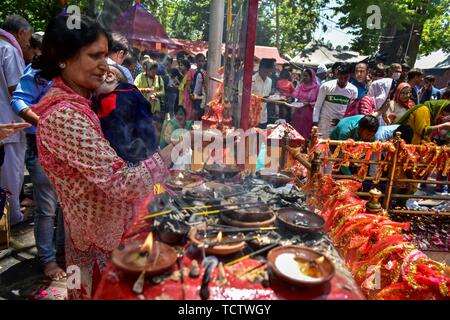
[112,233,177,275]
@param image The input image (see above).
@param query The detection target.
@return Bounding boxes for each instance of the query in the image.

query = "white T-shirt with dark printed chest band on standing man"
[313,79,358,139]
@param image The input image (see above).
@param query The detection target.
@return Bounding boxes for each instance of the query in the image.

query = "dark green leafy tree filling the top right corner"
[335,0,450,64]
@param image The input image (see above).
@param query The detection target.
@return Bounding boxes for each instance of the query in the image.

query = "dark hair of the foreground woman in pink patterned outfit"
[33,15,111,80]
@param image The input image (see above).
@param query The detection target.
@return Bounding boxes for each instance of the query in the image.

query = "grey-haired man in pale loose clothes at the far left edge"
[0,15,33,225]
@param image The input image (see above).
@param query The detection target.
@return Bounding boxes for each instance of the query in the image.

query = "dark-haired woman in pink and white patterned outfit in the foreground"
[33,16,173,299]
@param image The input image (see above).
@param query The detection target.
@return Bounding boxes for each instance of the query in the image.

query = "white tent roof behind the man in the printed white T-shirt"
[289,43,367,68]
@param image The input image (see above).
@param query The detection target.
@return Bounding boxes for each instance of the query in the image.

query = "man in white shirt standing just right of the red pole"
[252,58,275,129]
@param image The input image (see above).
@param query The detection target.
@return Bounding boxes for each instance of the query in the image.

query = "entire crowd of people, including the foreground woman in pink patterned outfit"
[0,10,450,298]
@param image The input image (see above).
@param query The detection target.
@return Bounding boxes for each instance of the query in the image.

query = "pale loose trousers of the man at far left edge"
[0,140,26,225]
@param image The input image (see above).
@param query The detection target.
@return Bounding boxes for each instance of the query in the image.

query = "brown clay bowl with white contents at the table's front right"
[267,246,335,287]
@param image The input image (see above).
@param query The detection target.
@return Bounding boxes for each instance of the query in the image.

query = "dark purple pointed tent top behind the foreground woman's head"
[111,3,173,48]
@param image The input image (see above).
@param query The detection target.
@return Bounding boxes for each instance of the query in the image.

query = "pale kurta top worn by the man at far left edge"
[0,40,25,143]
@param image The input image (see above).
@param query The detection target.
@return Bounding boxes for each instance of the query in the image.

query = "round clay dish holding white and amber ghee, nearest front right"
[267,245,335,287]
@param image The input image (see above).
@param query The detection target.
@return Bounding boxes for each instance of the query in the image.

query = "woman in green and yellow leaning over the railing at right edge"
[397,100,450,145]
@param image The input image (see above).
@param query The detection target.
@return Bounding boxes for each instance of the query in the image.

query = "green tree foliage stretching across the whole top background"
[0,0,450,59]
